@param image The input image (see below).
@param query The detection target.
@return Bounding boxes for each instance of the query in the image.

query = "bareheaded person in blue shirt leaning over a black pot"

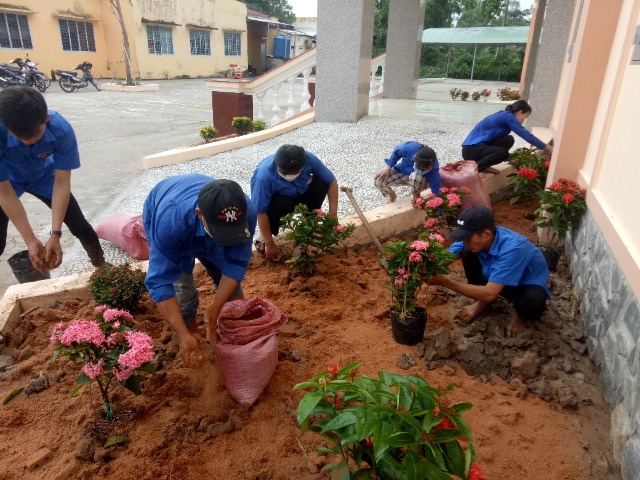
[0,87,105,271]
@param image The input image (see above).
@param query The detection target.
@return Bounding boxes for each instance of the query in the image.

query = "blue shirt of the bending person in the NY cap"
[142,173,257,302]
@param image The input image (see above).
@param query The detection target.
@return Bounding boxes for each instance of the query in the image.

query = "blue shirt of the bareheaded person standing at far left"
[0,111,80,198]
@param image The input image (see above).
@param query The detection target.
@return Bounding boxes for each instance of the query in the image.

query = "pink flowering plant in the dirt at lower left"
[51,305,155,420]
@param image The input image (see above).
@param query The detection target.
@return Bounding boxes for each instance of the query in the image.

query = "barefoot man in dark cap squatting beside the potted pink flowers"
[429,205,551,336]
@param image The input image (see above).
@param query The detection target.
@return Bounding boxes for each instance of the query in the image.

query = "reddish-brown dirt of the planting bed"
[0,199,619,480]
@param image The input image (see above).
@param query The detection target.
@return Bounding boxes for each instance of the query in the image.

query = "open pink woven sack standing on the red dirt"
[213,298,288,408]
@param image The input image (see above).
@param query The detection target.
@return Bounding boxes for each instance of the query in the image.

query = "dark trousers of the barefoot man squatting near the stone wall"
[460,249,547,322]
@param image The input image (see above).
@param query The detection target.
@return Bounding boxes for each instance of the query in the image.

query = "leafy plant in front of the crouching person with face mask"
[282,205,356,275]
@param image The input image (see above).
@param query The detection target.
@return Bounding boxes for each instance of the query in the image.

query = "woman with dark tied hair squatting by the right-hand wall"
[462,100,553,173]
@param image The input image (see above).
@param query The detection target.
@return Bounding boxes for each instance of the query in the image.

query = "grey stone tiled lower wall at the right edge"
[566,212,640,480]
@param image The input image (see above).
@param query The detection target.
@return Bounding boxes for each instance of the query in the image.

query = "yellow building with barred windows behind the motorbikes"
[0,0,247,79]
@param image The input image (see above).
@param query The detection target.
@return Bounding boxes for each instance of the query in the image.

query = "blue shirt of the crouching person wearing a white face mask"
[251,152,335,213]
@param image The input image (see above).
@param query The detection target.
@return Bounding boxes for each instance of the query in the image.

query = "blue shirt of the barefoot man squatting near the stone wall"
[449,227,551,298]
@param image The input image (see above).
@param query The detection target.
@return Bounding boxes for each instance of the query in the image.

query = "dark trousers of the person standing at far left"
[0,192,104,267]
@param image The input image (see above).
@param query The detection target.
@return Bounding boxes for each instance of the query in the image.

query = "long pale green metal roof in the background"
[422,26,529,45]
